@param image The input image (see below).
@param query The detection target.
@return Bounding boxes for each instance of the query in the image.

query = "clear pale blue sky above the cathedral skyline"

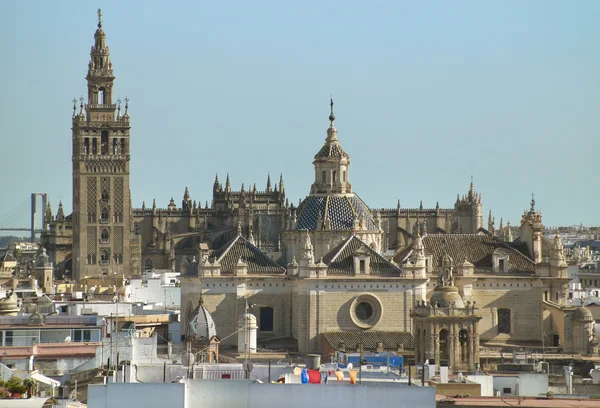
[0,0,600,227]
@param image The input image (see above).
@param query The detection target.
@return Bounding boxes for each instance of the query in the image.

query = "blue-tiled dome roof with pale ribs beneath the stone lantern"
[296,194,377,230]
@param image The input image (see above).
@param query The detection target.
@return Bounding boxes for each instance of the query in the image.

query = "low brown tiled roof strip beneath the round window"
[322,330,415,352]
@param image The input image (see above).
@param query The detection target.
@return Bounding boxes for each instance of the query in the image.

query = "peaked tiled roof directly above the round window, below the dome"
[323,235,401,276]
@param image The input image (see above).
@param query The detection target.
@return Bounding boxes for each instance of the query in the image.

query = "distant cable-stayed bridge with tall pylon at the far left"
[0,193,48,242]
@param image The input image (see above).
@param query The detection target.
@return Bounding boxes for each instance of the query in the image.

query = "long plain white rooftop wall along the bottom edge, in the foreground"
[88,380,435,408]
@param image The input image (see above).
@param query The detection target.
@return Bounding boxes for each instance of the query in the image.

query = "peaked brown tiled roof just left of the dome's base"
[215,235,285,275]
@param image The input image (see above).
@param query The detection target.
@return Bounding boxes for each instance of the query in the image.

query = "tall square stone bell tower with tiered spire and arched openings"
[72,10,133,280]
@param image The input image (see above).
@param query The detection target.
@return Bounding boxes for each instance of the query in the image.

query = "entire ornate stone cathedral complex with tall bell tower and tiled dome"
[42,12,594,370]
